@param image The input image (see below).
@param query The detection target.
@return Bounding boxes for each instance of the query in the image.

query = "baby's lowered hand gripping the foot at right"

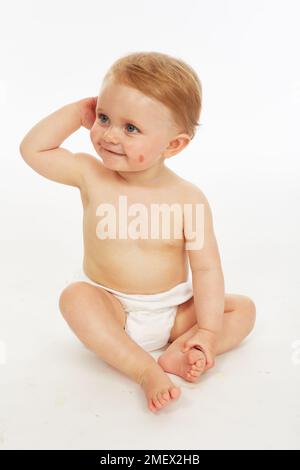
[181,329,216,370]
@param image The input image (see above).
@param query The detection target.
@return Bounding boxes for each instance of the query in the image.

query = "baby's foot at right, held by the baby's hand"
[157,343,206,382]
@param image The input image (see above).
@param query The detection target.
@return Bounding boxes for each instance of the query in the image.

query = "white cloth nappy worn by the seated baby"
[67,269,193,351]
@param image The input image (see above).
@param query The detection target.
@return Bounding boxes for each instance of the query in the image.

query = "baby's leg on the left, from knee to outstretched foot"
[59,282,180,411]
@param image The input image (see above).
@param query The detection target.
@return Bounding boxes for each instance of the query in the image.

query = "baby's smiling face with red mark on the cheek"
[90,78,188,171]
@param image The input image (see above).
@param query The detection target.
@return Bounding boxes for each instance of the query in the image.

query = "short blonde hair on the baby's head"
[104,52,202,139]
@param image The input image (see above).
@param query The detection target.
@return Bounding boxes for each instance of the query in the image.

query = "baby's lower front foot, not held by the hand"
[140,363,181,412]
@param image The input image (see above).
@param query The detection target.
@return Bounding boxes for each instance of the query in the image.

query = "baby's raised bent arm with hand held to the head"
[20,97,97,188]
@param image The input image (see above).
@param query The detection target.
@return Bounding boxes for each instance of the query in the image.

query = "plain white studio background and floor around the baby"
[0,0,300,449]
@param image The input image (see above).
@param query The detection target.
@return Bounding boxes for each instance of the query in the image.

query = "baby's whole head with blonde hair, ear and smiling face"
[90,52,202,175]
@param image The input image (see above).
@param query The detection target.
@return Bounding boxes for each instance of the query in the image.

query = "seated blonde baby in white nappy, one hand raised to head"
[20,52,256,412]
